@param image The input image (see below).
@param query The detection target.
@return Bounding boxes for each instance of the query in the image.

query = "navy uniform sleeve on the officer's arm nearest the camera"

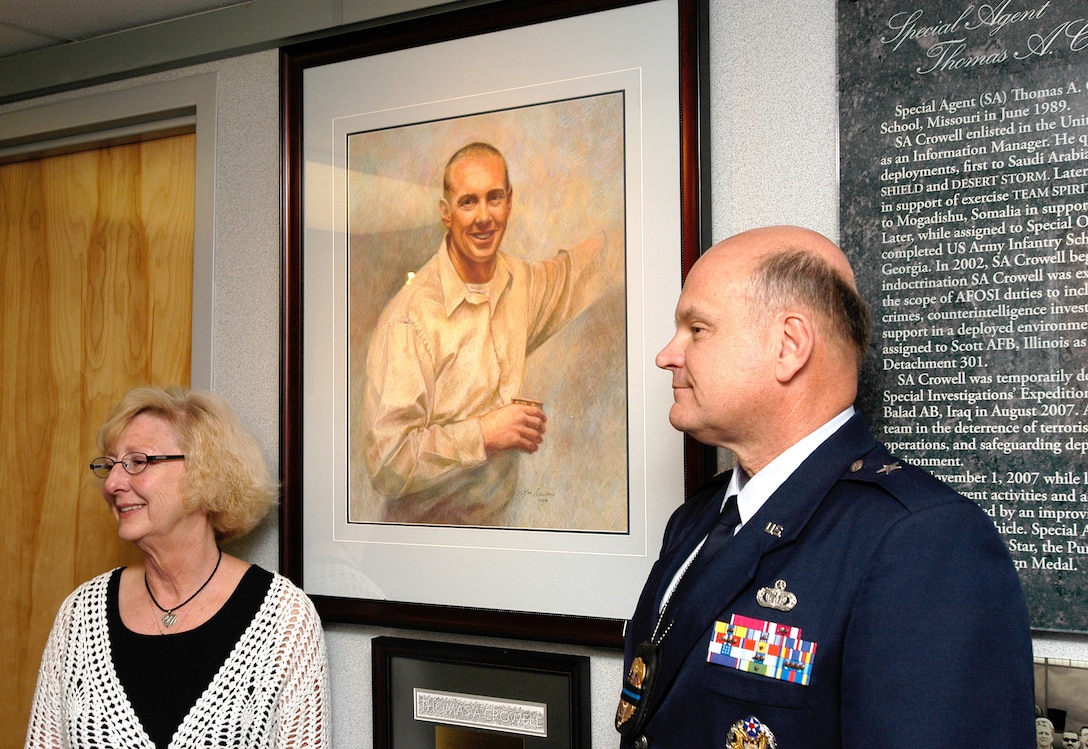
[841,501,1035,749]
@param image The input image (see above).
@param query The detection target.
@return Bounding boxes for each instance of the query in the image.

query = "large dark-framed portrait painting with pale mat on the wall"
[281,0,713,644]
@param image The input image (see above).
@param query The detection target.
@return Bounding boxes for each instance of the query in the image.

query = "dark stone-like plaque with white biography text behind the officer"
[839,0,1088,631]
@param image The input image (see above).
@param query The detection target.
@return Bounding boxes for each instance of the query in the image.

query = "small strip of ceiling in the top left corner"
[0,0,255,58]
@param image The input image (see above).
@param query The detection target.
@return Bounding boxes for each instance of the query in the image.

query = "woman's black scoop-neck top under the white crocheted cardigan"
[106,565,272,749]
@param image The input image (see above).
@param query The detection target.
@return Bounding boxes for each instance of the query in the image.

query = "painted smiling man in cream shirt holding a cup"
[363,143,619,526]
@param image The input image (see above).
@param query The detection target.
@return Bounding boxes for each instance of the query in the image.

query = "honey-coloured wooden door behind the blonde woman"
[0,134,196,749]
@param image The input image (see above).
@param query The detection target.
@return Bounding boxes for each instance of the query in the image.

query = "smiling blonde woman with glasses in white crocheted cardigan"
[26,388,329,749]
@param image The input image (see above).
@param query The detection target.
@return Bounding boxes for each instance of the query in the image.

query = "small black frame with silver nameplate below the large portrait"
[372,637,591,749]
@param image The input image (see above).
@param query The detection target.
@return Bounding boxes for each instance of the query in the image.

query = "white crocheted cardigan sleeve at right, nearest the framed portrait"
[275,588,332,749]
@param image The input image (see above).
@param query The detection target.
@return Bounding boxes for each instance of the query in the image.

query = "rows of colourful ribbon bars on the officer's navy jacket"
[706,614,816,687]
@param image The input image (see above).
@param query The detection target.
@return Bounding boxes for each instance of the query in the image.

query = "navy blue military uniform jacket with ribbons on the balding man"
[621,415,1035,749]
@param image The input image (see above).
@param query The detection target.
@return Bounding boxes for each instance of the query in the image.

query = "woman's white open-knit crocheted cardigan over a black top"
[26,573,330,749]
